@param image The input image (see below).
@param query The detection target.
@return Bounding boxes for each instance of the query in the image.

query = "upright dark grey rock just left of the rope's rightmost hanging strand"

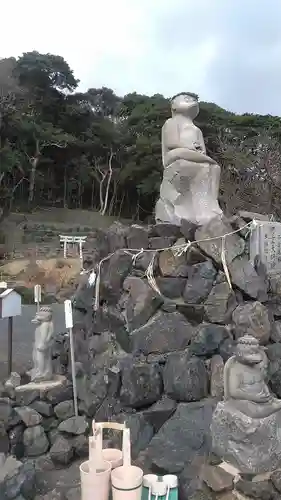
[183,260,217,304]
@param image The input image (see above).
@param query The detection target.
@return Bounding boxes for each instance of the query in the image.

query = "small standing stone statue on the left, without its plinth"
[30,307,54,382]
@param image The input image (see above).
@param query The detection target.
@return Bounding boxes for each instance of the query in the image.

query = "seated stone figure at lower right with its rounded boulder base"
[211,335,281,474]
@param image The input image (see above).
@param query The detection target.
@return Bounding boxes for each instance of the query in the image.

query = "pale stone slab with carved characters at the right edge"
[250,221,281,275]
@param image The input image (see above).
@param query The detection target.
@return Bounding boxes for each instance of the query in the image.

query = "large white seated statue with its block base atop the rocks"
[155,92,222,226]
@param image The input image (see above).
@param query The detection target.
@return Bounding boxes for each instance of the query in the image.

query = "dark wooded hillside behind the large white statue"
[0,51,281,220]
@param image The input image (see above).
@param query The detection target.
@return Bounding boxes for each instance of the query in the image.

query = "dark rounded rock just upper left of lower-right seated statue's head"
[190,323,230,356]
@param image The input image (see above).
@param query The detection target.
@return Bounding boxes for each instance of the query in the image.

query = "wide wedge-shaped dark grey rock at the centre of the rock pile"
[131,311,195,355]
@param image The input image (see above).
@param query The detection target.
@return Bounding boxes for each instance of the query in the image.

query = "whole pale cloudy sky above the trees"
[0,0,281,116]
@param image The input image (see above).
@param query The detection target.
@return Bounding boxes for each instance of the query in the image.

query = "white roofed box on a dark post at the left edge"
[0,288,21,376]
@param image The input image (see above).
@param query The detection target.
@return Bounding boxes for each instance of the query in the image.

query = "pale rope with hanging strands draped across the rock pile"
[94,220,261,311]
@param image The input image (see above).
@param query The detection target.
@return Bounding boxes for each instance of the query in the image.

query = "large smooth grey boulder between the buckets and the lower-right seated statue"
[144,400,215,474]
